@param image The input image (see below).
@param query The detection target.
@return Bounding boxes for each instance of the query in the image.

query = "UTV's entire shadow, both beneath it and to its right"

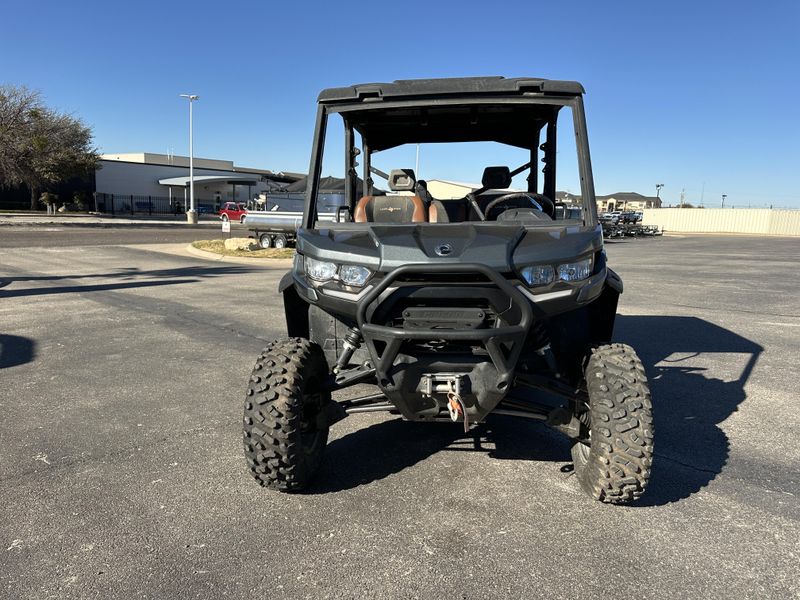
[309,316,763,506]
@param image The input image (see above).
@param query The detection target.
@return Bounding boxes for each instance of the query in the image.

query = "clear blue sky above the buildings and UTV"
[0,0,800,208]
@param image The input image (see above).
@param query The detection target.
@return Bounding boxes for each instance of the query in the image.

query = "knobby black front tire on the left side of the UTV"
[243,338,331,492]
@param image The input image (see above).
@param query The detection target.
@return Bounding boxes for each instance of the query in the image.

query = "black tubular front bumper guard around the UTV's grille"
[356,263,534,420]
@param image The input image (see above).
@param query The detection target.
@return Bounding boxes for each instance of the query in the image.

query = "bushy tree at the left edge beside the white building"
[0,85,100,210]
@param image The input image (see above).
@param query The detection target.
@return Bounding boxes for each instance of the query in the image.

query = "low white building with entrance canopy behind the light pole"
[95,152,301,210]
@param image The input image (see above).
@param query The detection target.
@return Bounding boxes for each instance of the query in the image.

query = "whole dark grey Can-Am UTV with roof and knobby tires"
[244,77,653,503]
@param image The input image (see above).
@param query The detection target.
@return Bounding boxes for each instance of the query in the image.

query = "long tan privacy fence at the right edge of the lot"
[642,208,800,236]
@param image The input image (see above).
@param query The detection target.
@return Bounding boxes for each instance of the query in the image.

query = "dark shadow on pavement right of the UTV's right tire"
[615,316,763,506]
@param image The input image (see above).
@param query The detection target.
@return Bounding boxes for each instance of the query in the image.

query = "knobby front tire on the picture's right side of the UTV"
[572,344,653,504]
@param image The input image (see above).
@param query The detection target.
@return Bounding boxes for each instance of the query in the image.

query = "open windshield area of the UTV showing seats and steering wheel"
[314,103,587,226]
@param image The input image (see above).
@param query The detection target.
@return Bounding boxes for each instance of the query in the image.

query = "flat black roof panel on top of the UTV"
[318,77,584,103]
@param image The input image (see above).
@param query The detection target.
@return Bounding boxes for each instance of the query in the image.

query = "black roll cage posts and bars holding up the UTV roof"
[302,95,598,229]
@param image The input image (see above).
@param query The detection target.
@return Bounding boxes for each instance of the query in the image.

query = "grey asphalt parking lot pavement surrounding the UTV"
[0,227,800,599]
